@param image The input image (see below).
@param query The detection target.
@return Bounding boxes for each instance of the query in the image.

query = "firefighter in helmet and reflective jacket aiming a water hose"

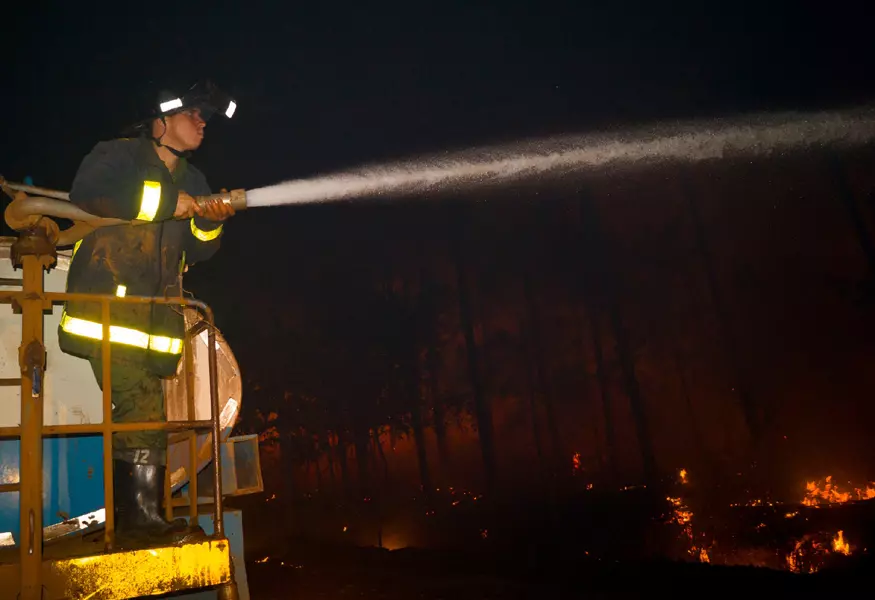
[58,82,236,545]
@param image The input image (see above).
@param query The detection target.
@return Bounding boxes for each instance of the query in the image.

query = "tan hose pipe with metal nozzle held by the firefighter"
[0,177,246,246]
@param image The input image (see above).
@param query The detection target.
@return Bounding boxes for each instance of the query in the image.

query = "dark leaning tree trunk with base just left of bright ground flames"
[580,194,657,482]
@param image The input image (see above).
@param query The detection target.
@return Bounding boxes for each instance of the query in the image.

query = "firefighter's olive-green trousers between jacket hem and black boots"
[89,358,167,465]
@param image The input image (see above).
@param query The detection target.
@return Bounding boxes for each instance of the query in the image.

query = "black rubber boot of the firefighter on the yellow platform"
[113,460,205,546]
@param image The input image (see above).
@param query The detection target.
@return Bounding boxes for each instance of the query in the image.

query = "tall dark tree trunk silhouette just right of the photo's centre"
[452,206,496,493]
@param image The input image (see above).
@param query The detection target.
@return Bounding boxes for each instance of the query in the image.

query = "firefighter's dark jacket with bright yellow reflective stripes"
[58,138,222,376]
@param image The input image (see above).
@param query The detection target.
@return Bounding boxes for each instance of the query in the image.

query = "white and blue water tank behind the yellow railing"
[0,237,242,545]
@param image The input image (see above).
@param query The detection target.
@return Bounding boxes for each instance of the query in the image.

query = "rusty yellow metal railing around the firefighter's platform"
[0,268,225,600]
